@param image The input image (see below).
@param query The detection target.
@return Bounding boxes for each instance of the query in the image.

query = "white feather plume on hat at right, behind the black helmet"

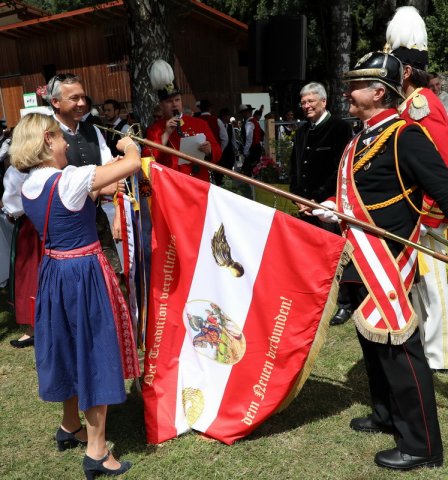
[386,7,428,50]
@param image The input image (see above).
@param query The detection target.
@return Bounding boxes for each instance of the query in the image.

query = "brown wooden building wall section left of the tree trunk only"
[0,19,131,126]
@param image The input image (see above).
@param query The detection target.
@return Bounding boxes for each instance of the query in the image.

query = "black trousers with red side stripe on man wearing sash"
[349,283,443,457]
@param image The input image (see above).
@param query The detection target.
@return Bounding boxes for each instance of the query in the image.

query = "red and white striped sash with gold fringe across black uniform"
[337,135,420,345]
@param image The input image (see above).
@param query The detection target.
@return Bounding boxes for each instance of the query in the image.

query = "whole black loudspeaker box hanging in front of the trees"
[249,15,307,83]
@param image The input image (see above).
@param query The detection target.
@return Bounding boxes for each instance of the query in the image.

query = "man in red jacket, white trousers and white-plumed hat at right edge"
[386,7,448,370]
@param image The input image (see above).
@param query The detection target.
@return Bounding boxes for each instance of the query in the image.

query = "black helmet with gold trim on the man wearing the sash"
[343,52,404,98]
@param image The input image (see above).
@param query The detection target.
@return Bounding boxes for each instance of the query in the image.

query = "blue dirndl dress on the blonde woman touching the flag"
[22,173,126,411]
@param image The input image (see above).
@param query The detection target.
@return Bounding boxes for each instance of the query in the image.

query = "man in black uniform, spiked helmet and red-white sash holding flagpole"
[313,52,448,470]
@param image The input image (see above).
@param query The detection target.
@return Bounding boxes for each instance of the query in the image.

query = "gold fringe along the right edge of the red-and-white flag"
[275,242,353,413]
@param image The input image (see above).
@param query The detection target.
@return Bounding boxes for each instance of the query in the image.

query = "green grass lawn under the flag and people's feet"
[0,284,448,480]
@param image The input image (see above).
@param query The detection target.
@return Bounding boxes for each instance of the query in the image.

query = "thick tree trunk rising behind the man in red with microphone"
[125,0,174,129]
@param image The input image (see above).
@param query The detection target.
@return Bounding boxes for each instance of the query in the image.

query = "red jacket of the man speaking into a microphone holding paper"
[142,115,222,182]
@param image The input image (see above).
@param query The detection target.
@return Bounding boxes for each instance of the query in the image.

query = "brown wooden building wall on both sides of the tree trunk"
[0,9,254,126]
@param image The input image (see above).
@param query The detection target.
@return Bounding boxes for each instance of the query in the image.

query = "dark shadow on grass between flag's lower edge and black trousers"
[245,360,370,441]
